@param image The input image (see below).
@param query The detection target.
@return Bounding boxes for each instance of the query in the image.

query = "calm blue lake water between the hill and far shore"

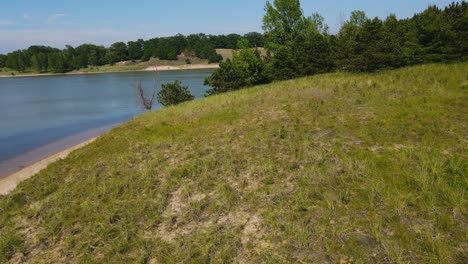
[0,70,213,163]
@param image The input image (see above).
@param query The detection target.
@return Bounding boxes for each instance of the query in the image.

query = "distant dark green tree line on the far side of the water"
[0,32,264,73]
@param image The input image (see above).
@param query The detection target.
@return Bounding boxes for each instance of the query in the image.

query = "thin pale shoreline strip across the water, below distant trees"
[0,63,219,78]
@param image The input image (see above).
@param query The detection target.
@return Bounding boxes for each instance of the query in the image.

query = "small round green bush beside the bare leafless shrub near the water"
[157,80,195,106]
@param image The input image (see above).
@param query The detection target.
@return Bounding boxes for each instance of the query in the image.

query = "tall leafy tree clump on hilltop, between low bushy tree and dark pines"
[263,0,334,80]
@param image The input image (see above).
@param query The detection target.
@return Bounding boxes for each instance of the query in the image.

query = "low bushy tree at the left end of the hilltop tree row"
[205,39,269,96]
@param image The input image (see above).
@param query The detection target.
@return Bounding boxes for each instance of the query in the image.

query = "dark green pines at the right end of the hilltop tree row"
[333,1,468,71]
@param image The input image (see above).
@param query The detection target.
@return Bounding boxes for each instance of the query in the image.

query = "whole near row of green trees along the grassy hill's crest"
[205,0,468,95]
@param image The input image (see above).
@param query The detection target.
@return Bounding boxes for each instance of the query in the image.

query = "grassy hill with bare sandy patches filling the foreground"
[0,64,468,263]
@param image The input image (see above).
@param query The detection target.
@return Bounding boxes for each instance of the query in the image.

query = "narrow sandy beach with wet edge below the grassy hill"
[0,124,117,195]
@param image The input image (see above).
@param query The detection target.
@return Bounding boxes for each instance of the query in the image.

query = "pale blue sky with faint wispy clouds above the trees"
[0,0,461,54]
